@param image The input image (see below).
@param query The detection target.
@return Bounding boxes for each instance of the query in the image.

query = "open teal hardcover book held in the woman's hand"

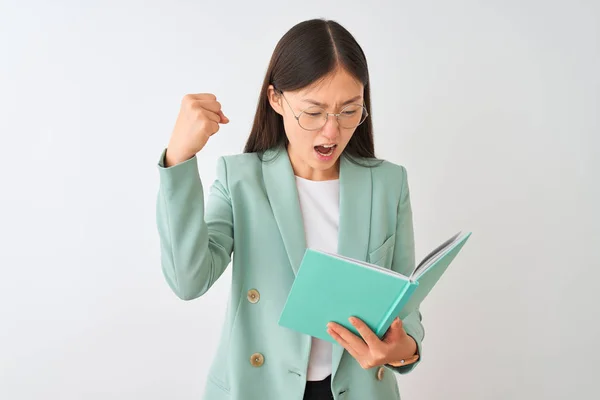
[279,232,471,343]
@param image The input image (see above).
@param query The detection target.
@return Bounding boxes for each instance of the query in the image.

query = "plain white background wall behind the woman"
[0,0,600,400]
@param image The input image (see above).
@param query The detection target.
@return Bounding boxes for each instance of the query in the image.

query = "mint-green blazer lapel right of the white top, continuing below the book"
[332,153,372,379]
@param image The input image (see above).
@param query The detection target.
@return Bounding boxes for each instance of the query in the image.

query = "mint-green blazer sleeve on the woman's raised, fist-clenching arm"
[156,149,233,300]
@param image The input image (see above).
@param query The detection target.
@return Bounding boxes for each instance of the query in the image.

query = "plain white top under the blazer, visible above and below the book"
[296,176,340,381]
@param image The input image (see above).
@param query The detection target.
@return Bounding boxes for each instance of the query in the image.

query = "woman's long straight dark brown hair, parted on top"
[244,19,375,158]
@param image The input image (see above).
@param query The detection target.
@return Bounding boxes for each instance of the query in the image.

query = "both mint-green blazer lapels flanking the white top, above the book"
[262,148,372,275]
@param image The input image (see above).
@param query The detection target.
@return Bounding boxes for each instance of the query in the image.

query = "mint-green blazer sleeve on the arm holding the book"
[386,167,425,374]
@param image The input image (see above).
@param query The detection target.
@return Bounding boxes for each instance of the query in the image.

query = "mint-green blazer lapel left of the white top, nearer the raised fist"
[262,148,306,275]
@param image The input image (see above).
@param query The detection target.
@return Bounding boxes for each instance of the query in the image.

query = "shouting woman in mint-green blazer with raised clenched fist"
[157,19,424,400]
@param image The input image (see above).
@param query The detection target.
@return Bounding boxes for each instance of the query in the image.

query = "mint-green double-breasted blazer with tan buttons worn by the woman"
[156,148,424,400]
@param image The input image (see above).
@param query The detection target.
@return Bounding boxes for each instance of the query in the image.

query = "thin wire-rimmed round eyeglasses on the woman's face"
[277,89,369,131]
